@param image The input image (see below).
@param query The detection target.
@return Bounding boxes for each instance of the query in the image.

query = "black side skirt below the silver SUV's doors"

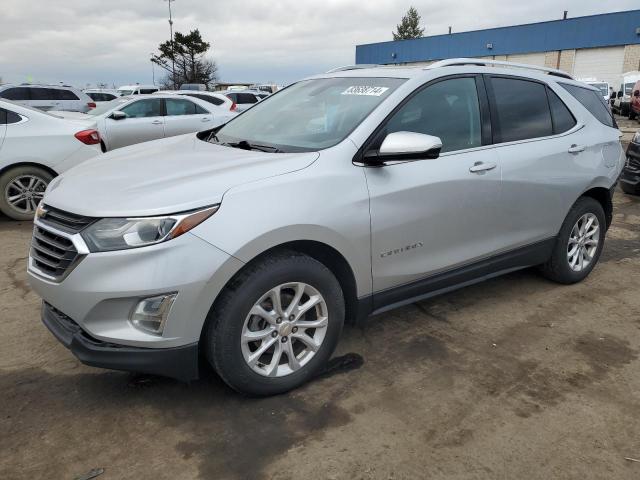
[357,237,556,320]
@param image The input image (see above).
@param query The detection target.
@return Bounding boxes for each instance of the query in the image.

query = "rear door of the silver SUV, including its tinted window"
[485,76,591,250]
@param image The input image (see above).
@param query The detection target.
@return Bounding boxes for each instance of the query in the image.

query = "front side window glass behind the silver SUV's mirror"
[374,78,482,152]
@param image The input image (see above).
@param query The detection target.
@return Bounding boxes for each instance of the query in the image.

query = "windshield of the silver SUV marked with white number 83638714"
[211,78,406,152]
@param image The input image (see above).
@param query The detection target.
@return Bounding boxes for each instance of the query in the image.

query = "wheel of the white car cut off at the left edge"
[0,165,54,220]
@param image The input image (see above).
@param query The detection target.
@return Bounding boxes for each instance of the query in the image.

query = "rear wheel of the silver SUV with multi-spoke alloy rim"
[540,197,606,284]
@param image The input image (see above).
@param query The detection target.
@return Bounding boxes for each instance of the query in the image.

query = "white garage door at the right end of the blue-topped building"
[573,47,624,85]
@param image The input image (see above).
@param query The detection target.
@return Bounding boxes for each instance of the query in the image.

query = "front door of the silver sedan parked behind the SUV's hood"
[105,98,164,150]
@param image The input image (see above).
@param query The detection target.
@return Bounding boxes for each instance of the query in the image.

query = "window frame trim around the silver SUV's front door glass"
[352,73,492,168]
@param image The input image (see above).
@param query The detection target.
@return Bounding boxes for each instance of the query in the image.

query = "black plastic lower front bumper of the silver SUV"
[42,302,198,381]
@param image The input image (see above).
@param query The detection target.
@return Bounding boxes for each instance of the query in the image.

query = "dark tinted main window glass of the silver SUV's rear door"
[491,77,553,143]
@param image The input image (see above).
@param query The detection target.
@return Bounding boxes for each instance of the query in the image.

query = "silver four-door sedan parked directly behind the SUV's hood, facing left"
[56,93,231,152]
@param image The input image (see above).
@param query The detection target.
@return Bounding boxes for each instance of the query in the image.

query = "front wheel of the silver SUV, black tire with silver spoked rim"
[204,251,345,396]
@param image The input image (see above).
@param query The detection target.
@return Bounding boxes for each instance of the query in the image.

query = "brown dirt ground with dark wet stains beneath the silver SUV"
[0,117,640,480]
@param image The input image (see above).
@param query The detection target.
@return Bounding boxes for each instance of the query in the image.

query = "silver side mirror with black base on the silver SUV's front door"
[378,132,442,162]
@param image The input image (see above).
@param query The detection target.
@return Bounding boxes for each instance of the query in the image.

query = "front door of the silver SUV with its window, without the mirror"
[365,76,501,292]
